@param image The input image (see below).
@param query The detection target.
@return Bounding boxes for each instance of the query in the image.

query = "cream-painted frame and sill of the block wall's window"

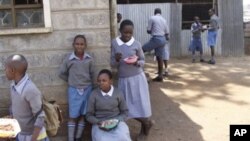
[0,0,53,35]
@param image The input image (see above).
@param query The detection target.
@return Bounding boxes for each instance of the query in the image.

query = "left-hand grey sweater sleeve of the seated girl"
[86,93,99,124]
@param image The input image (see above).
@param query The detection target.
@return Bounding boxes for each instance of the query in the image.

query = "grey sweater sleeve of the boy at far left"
[26,89,45,128]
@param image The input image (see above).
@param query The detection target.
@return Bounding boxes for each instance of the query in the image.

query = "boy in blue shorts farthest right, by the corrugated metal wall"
[207,9,219,64]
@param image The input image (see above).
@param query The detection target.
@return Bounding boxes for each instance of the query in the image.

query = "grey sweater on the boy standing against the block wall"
[59,52,94,89]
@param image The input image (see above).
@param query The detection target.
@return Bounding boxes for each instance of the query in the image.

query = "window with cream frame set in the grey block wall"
[0,0,52,35]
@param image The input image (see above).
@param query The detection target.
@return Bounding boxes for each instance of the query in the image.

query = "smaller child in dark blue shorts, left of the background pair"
[189,16,204,63]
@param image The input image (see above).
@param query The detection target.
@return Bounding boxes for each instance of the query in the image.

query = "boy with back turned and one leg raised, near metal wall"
[142,8,169,82]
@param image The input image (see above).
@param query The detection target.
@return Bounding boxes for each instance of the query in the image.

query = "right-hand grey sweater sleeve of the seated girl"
[117,92,128,121]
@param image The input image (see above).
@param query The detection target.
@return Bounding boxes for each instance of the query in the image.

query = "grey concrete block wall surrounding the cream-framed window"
[0,0,110,139]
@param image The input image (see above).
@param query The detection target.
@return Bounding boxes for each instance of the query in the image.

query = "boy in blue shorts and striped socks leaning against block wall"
[59,35,95,141]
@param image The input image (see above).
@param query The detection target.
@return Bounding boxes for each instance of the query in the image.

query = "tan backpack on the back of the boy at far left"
[42,97,63,137]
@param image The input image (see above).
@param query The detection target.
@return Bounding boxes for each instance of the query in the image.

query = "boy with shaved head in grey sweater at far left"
[5,55,48,141]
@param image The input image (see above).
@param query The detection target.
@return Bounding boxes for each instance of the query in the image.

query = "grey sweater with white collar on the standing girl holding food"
[110,37,145,78]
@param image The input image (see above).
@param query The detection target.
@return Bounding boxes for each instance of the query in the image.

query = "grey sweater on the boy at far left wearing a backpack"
[10,74,45,135]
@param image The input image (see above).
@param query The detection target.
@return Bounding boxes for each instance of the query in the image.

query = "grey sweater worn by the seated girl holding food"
[86,88,128,124]
